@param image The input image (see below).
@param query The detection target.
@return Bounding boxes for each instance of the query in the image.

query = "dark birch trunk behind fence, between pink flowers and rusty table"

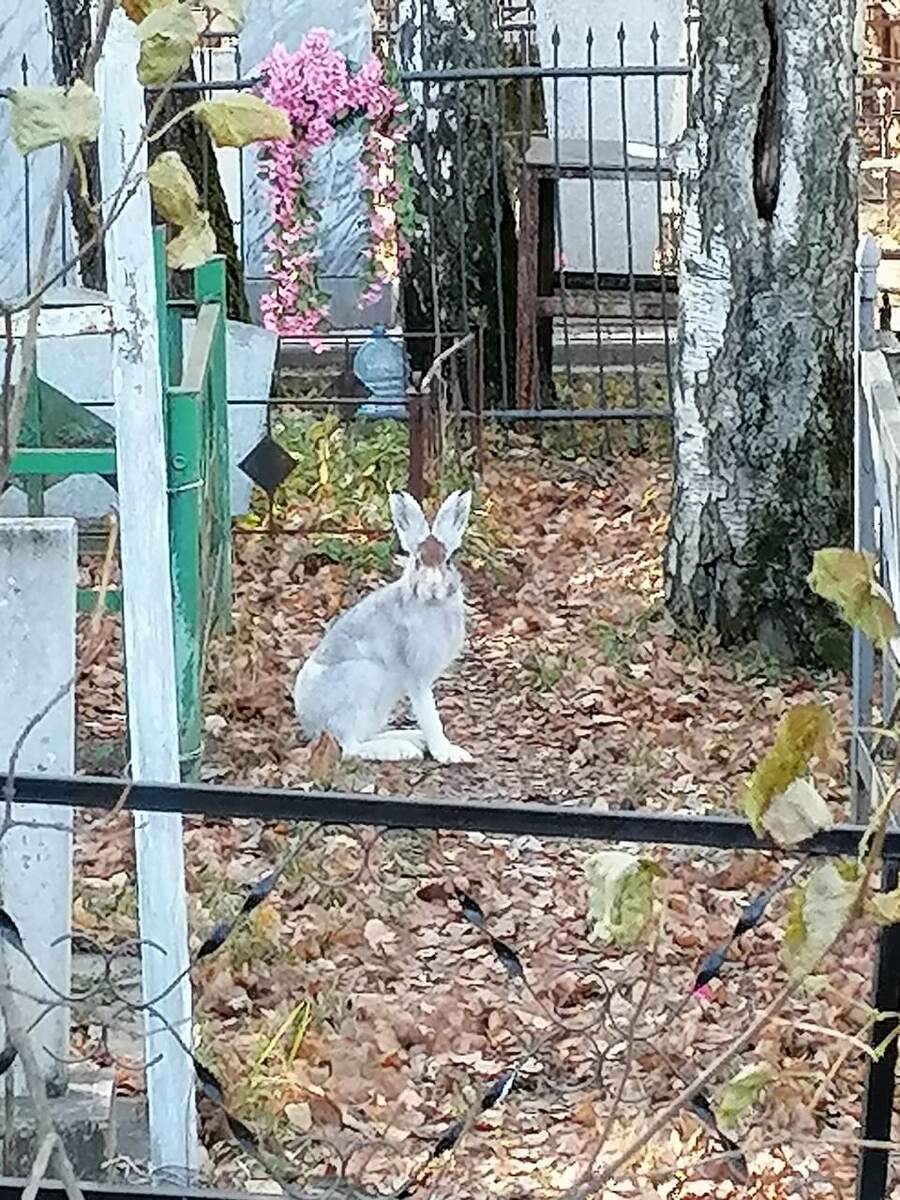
[397,0,516,406]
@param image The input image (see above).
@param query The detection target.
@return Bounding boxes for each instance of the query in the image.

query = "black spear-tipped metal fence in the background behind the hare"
[5,10,692,421]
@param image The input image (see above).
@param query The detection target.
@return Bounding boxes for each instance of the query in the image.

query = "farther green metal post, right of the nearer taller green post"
[194,257,232,629]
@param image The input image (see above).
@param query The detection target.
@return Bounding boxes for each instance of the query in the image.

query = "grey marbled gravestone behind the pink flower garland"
[240,0,394,329]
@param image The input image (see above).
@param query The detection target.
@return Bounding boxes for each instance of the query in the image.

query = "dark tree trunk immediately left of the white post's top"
[46,0,106,292]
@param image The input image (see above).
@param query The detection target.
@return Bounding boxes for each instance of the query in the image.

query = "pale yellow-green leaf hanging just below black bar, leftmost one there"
[584,850,662,949]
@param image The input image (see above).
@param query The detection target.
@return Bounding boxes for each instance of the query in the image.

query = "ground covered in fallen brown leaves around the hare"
[77,446,892,1200]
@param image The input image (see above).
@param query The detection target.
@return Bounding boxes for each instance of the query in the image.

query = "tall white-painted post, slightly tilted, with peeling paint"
[98,8,197,1172]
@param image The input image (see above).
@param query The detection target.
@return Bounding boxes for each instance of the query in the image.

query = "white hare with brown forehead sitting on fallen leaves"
[294,492,472,763]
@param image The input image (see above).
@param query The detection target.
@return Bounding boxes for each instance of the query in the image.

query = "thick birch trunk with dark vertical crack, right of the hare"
[666,0,857,661]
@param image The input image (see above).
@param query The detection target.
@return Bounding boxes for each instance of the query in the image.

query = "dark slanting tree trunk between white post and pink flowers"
[146,64,250,322]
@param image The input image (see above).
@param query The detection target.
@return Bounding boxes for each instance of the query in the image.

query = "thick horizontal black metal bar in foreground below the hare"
[0,775,900,858]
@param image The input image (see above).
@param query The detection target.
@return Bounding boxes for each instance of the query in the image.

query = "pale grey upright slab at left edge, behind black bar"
[0,517,78,1094]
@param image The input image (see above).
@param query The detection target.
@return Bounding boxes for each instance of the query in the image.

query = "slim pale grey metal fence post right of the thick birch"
[850,234,881,822]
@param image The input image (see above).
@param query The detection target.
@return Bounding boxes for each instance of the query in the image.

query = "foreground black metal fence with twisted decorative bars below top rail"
[0,776,900,1200]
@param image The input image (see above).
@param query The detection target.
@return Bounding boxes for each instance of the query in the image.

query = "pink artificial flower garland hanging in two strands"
[259,29,412,346]
